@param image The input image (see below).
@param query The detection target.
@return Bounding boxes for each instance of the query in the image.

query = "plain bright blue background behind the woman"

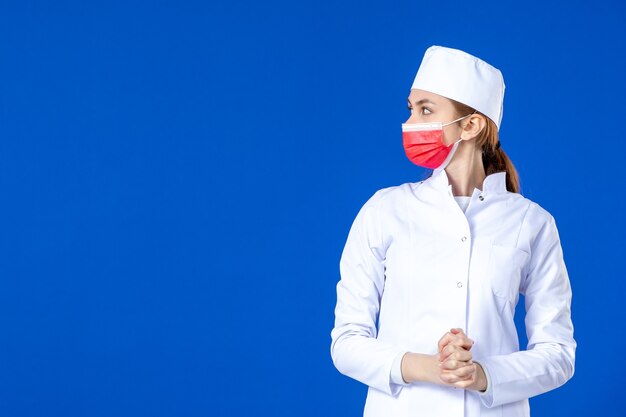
[0,0,626,417]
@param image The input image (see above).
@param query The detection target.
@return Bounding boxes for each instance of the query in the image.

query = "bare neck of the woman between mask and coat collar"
[445,141,486,196]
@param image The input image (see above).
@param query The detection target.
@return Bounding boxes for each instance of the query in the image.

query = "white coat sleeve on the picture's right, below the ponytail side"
[479,216,576,407]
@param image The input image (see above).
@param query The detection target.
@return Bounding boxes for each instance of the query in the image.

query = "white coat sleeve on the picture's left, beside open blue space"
[330,192,405,396]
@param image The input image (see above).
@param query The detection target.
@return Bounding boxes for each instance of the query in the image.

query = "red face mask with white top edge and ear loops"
[402,114,471,169]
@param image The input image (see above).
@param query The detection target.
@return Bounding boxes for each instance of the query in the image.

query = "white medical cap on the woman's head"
[411,46,504,130]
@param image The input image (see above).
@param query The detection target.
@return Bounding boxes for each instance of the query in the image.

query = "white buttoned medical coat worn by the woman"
[331,170,576,417]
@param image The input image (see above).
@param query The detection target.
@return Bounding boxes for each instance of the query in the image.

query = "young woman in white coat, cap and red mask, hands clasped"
[331,46,576,417]
